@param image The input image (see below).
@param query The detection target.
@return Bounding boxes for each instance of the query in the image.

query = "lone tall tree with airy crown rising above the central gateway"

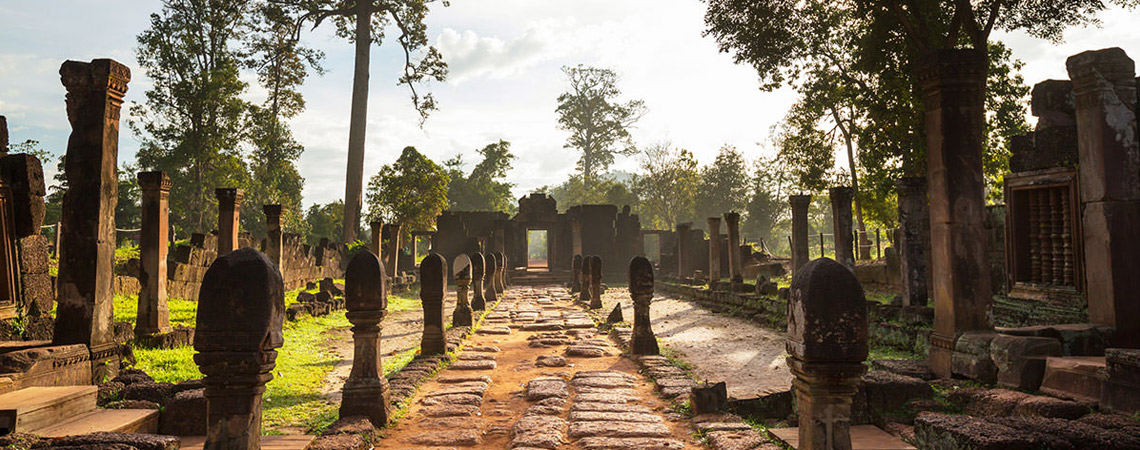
[555,65,645,187]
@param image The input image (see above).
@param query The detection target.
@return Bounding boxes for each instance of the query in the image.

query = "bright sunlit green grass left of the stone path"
[122,283,420,434]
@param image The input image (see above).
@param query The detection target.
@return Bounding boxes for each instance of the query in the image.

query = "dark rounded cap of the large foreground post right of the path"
[787,257,868,362]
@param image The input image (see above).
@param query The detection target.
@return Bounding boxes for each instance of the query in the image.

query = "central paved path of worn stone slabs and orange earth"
[381,288,702,450]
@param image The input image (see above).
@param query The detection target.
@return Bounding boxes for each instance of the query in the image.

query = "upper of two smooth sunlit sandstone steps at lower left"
[0,386,99,434]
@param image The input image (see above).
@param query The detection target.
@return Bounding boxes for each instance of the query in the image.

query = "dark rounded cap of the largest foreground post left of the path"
[194,247,285,377]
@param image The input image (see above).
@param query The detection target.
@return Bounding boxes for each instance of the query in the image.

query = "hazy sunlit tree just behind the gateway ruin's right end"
[634,142,701,230]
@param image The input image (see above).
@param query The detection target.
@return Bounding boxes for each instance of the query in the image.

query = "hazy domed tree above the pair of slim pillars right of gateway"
[693,145,751,227]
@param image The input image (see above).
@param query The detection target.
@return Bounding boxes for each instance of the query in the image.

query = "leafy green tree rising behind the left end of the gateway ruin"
[443,140,515,212]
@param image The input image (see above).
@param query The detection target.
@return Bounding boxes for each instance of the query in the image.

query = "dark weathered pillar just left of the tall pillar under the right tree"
[897,177,930,306]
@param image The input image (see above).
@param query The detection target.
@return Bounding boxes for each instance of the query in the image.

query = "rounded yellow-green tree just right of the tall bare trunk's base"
[367,147,448,242]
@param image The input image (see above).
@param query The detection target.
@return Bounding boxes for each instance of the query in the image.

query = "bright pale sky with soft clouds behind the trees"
[0,0,1140,209]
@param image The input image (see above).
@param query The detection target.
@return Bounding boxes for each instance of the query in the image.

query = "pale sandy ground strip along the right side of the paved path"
[602,287,792,399]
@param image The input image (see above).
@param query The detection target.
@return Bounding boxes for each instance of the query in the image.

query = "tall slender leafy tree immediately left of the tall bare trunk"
[242,2,324,236]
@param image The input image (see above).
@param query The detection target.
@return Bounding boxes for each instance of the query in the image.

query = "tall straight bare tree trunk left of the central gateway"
[341,0,372,243]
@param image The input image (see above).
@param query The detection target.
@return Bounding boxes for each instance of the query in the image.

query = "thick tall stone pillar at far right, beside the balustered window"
[1066,48,1140,349]
